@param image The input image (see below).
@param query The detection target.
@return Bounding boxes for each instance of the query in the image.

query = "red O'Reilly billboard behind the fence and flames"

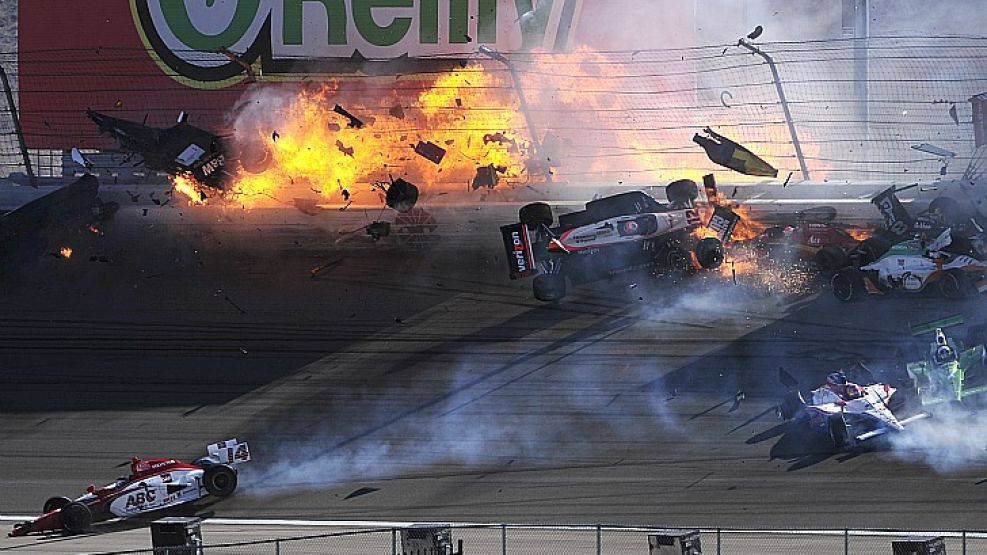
[18,0,583,149]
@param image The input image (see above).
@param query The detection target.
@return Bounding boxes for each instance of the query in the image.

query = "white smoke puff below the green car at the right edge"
[890,405,987,474]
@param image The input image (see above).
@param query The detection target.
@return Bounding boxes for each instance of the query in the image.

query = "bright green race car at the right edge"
[905,328,987,405]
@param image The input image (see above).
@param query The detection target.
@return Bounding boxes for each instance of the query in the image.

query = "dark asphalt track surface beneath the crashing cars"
[0,202,987,553]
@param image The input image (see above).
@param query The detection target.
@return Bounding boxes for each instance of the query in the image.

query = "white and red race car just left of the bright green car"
[777,370,929,449]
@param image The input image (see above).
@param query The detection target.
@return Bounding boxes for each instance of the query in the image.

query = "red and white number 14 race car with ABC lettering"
[9,439,250,536]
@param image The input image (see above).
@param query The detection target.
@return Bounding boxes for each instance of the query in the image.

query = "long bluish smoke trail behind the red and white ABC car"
[242,282,763,495]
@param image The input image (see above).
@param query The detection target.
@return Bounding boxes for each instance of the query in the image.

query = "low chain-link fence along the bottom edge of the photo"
[90,524,987,555]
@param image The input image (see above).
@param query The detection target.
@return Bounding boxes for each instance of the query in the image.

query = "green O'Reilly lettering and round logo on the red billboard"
[131,0,582,81]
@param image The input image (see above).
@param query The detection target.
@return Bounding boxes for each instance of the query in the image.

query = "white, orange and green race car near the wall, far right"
[830,228,987,302]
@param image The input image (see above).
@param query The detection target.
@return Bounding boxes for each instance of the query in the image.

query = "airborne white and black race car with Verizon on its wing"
[500,179,740,301]
